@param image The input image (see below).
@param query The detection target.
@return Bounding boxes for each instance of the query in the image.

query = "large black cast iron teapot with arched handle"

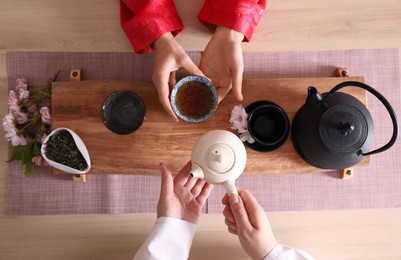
[291,81,398,169]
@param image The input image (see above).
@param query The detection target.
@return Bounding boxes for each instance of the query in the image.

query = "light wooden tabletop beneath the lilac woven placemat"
[0,0,401,259]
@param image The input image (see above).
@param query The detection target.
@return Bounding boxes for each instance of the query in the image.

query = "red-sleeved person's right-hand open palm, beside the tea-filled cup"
[199,26,244,102]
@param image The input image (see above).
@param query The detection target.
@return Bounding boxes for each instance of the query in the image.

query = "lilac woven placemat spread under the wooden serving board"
[6,49,401,215]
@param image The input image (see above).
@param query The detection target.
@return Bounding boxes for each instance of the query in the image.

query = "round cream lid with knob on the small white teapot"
[206,143,235,173]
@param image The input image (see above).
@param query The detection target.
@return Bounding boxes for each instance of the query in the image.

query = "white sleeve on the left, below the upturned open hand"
[134,217,196,260]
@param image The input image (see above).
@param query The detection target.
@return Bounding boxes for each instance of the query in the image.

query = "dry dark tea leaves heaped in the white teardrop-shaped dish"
[46,130,88,171]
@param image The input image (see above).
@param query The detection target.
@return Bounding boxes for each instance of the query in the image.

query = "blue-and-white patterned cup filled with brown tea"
[170,75,218,123]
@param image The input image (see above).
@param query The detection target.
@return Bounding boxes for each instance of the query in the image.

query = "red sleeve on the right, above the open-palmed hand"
[198,0,266,41]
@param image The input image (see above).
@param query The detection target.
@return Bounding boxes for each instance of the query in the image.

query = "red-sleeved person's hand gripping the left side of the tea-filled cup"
[152,32,204,122]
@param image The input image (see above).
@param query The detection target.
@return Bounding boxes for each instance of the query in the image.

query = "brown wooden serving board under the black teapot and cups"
[52,77,369,176]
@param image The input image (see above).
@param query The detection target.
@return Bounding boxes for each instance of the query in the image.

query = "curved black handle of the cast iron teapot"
[324,81,398,156]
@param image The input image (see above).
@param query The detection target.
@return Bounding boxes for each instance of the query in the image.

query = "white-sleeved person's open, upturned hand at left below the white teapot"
[157,162,213,224]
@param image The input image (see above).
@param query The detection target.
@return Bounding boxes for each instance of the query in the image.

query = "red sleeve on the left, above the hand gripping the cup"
[120,0,184,53]
